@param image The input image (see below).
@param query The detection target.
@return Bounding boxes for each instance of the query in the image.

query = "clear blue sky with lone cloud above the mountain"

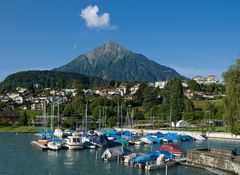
[0,0,240,80]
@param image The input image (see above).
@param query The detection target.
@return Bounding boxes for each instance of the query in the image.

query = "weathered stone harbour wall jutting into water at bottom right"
[187,148,240,175]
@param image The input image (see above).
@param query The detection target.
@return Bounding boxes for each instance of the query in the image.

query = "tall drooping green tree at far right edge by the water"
[223,59,240,134]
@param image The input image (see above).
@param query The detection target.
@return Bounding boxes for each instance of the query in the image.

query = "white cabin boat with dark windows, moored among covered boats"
[64,136,83,149]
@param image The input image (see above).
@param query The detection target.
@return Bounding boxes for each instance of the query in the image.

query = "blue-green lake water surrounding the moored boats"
[0,133,240,175]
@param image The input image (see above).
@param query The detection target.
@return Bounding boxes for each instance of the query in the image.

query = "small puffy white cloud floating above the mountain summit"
[80,5,116,30]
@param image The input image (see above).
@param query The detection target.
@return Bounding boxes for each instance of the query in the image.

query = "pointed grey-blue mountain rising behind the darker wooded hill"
[56,40,184,82]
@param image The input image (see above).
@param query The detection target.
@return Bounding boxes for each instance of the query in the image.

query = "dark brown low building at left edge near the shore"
[0,112,20,125]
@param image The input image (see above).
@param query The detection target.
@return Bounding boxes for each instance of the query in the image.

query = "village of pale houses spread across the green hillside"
[0,75,224,125]
